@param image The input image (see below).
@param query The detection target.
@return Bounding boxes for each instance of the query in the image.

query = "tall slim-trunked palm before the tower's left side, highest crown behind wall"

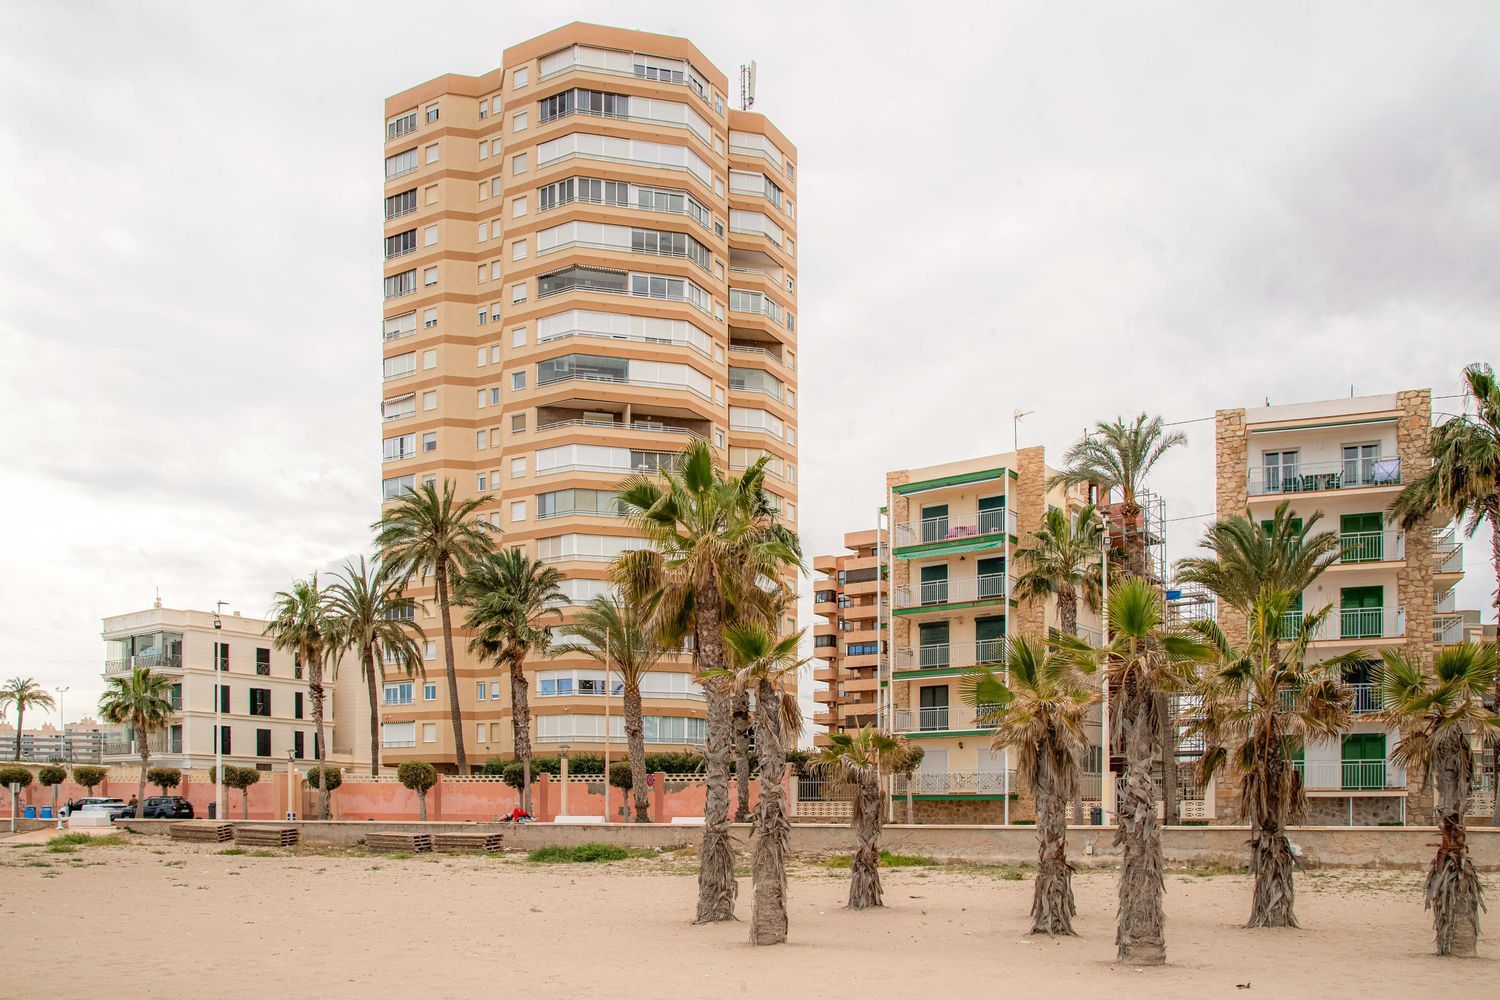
[372,480,494,774]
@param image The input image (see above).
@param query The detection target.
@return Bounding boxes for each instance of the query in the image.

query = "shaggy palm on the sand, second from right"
[1188,583,1365,927]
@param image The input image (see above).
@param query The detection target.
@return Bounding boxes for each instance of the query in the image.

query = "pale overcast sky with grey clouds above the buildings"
[0,0,1500,731]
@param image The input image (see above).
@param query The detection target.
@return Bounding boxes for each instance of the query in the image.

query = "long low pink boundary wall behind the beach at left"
[11,772,780,823]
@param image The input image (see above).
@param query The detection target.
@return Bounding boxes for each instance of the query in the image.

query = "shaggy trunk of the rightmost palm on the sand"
[1427,729,1484,958]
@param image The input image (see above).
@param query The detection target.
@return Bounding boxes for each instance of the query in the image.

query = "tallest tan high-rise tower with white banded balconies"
[381,24,797,765]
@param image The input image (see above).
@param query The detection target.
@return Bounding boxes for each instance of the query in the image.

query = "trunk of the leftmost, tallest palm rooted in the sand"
[693,579,740,924]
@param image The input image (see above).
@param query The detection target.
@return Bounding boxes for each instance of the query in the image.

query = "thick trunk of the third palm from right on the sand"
[1115,685,1167,966]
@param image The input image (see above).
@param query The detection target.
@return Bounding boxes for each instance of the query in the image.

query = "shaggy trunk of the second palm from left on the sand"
[750,681,792,945]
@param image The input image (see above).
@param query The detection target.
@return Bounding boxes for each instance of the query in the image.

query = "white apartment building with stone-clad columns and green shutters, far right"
[1217,388,1464,825]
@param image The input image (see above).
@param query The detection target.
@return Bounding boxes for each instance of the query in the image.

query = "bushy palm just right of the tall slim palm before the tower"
[459,547,564,813]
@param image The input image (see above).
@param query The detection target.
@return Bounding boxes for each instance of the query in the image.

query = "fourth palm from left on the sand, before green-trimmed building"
[963,636,1098,937]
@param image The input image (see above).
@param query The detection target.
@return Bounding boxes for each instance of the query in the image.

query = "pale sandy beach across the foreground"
[0,837,1500,999]
